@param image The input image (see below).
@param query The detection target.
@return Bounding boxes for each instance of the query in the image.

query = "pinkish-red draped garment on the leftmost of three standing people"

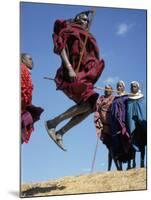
[94,95,114,146]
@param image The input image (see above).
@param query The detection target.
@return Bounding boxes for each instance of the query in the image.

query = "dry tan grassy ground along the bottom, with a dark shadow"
[21,168,147,197]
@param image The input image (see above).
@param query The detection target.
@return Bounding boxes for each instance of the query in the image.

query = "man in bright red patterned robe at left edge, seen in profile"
[21,53,43,143]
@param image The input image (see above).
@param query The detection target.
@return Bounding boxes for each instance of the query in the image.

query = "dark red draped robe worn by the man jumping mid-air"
[53,20,104,107]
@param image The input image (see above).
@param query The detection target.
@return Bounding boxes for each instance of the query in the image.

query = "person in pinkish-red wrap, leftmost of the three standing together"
[94,85,115,171]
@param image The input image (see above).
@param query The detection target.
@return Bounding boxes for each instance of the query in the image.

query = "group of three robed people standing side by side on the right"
[94,81,146,169]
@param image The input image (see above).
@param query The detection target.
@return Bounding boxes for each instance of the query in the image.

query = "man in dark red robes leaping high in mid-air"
[46,11,104,150]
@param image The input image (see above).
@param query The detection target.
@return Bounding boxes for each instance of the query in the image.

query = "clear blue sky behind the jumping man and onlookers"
[20,2,146,182]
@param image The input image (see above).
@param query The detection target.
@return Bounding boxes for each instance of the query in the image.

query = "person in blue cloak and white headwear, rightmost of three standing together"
[127,81,147,168]
